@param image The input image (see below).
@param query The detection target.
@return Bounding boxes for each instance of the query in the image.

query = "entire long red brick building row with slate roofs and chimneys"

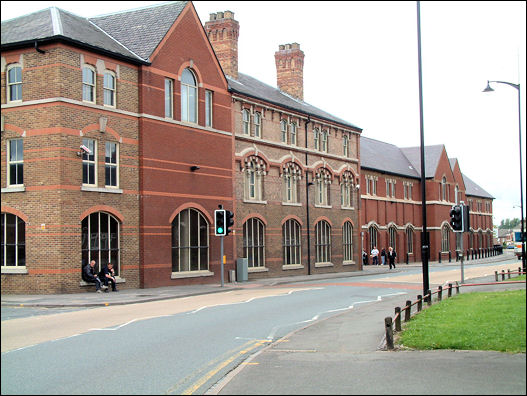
[0,1,493,293]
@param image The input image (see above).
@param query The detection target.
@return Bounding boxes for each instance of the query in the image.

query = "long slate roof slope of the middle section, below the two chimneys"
[227,73,361,130]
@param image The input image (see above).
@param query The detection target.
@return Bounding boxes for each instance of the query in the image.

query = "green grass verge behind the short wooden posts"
[397,290,526,353]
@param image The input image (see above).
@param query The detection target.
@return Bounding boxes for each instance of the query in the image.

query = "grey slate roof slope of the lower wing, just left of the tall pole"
[360,136,420,178]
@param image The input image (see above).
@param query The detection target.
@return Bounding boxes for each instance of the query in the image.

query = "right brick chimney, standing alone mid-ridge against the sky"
[274,43,304,100]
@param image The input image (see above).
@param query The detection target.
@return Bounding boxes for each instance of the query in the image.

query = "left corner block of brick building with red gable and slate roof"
[1,2,234,293]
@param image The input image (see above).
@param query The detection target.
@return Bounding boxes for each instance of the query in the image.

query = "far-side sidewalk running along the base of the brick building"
[1,254,517,308]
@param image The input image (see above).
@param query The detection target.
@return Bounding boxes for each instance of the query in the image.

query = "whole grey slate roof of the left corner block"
[2,1,188,63]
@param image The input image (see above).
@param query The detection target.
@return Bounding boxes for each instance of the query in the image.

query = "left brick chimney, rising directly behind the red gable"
[205,11,240,79]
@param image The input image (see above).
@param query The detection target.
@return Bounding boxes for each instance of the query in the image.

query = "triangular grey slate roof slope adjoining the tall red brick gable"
[88,1,188,61]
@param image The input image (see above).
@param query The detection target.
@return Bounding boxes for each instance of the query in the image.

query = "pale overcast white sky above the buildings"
[1,1,527,229]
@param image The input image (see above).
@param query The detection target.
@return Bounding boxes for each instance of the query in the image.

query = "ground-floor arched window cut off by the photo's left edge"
[1,213,26,269]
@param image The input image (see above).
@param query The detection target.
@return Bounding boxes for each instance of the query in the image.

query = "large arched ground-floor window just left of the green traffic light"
[172,208,209,272]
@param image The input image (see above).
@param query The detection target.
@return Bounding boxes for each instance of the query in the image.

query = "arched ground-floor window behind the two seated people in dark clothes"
[81,212,120,276]
